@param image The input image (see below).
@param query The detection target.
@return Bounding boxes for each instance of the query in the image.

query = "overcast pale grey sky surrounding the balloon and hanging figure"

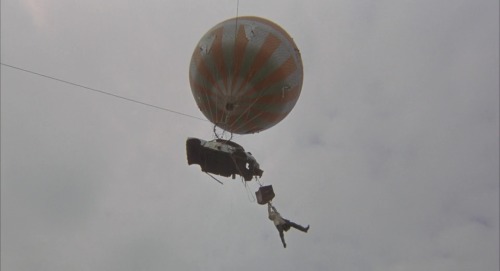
[1,0,499,271]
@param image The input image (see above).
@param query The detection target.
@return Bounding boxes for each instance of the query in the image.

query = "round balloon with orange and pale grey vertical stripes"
[189,17,303,134]
